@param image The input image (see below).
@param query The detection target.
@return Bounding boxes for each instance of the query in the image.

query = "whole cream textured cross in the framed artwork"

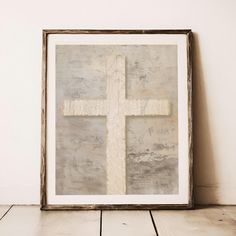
[63,55,170,195]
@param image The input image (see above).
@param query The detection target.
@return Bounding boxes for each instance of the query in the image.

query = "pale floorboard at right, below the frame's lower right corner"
[152,207,236,236]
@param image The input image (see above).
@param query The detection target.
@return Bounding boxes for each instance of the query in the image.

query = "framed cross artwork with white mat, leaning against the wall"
[41,30,193,210]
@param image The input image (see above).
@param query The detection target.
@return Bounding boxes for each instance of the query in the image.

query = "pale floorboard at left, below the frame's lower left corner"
[0,206,100,236]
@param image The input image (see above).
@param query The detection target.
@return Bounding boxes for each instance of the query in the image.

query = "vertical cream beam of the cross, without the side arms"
[106,56,126,194]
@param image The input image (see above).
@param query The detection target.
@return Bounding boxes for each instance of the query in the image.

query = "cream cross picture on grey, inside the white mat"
[56,45,179,195]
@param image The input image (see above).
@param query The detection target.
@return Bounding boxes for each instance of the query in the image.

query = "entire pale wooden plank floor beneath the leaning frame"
[0,206,236,236]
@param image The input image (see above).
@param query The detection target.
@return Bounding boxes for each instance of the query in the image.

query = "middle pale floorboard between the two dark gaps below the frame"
[102,211,156,236]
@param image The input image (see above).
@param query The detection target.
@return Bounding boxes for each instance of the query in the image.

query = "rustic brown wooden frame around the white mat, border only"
[40,29,194,210]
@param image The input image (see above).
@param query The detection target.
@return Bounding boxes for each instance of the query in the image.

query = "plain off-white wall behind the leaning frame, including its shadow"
[0,0,236,204]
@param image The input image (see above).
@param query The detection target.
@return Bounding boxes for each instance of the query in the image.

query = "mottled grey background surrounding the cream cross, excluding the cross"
[56,45,178,194]
